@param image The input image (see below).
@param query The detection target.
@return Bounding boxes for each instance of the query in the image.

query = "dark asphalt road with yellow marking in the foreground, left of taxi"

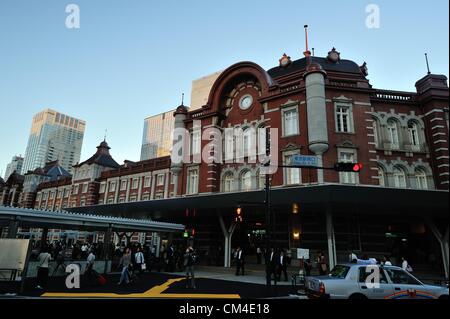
[0,273,302,299]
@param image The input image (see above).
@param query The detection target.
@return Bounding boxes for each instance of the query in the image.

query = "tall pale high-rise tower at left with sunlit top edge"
[22,109,86,174]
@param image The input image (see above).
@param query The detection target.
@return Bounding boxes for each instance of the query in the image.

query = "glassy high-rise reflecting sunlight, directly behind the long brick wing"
[141,110,175,161]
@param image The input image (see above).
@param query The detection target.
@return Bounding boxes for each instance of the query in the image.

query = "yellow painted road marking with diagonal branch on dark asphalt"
[41,278,241,299]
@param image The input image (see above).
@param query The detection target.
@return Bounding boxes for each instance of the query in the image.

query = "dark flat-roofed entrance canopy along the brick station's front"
[67,184,448,276]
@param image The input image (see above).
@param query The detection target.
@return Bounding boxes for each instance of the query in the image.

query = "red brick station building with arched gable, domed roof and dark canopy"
[0,48,449,276]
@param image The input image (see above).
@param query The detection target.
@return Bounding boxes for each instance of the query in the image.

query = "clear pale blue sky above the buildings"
[0,0,449,172]
